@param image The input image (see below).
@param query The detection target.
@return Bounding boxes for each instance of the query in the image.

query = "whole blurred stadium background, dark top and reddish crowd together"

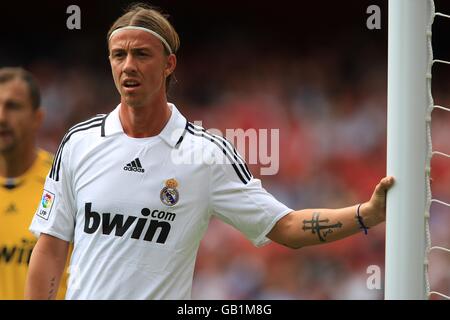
[0,0,450,299]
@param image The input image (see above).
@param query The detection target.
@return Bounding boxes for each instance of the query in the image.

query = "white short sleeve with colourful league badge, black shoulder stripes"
[29,141,75,242]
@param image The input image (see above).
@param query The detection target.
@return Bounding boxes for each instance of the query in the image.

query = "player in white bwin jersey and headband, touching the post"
[26,5,393,299]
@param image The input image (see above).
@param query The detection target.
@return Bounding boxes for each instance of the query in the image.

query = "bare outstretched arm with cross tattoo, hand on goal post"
[267,177,394,248]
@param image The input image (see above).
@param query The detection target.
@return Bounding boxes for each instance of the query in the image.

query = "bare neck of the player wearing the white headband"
[119,99,171,138]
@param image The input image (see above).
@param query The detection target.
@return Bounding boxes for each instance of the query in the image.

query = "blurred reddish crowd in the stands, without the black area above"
[24,31,450,299]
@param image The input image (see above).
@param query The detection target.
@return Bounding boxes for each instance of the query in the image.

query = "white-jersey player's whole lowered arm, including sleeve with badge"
[25,126,84,299]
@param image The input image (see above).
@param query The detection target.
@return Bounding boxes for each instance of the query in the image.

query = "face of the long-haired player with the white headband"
[109,30,176,108]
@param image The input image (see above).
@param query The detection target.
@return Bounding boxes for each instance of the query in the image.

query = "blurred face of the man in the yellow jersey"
[0,79,42,153]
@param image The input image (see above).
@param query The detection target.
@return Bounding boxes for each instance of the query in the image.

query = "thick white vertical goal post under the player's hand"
[385,0,431,300]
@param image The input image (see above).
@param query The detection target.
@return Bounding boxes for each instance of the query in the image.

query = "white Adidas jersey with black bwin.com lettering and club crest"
[30,104,292,299]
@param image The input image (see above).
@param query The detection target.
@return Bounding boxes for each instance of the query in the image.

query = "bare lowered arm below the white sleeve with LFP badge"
[25,233,69,300]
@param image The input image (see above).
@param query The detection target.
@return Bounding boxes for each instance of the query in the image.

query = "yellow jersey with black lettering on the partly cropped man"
[0,150,66,300]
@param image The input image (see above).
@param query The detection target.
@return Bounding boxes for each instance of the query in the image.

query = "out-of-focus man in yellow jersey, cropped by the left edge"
[0,68,66,300]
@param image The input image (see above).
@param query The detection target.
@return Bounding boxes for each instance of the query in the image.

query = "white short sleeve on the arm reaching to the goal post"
[210,142,293,246]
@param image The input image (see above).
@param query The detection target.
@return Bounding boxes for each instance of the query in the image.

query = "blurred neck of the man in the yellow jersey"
[0,144,37,178]
